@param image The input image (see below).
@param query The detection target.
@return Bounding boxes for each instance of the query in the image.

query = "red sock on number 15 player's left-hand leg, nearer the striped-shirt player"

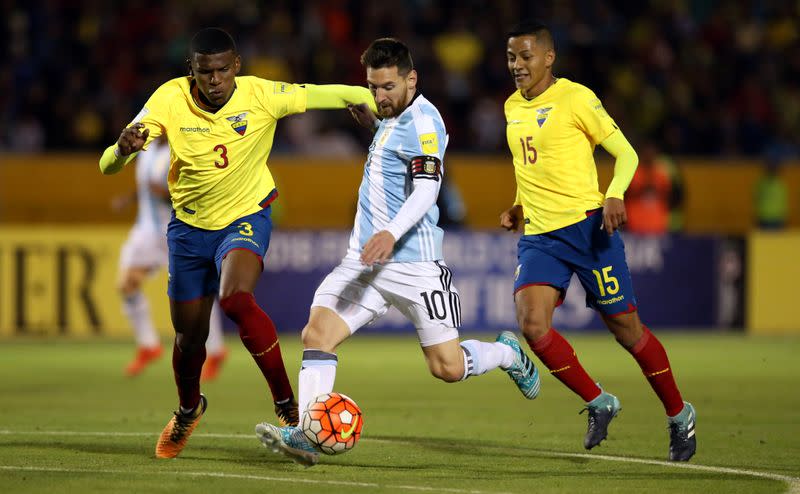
[528,328,602,402]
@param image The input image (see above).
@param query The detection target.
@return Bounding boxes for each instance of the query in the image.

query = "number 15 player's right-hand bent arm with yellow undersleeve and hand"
[600,130,639,235]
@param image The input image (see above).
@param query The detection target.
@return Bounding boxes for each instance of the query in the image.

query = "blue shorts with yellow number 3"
[167,207,272,302]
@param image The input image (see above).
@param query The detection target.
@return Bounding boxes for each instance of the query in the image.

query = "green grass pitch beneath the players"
[0,332,800,494]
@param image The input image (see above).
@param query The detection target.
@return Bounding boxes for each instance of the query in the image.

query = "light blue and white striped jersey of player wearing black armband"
[346,93,447,262]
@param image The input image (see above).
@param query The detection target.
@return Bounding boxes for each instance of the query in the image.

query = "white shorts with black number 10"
[311,259,461,347]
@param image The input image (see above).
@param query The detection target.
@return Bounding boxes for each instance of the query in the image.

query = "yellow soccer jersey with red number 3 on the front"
[133,76,307,230]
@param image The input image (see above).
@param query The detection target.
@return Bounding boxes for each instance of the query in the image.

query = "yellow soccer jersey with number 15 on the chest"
[505,78,617,235]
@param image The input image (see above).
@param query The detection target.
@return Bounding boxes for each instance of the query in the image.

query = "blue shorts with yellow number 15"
[514,210,636,316]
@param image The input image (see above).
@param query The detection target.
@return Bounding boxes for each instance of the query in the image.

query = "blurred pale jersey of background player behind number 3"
[136,140,172,233]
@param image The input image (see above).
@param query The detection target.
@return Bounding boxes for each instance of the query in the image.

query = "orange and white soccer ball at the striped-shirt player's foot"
[300,393,364,455]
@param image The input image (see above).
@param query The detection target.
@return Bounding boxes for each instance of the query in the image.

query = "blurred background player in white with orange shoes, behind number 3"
[112,138,227,381]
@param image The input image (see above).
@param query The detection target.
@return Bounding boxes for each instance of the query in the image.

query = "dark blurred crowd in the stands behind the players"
[0,0,800,158]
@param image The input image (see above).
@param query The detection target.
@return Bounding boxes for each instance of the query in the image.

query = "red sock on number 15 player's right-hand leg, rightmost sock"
[628,325,683,417]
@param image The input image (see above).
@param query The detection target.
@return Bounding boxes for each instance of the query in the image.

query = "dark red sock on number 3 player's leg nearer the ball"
[219,292,294,401]
